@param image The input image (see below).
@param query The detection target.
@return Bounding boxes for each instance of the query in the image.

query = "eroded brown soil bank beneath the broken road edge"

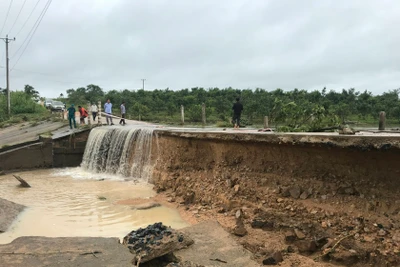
[153,131,400,266]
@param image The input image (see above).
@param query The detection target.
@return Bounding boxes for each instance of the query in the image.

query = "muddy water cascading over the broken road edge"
[81,126,154,182]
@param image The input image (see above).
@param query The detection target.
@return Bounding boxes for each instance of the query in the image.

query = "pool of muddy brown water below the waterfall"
[0,168,188,244]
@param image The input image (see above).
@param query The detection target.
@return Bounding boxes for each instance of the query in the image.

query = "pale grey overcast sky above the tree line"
[0,0,400,97]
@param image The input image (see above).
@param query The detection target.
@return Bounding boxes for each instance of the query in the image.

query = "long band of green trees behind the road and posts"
[67,85,400,131]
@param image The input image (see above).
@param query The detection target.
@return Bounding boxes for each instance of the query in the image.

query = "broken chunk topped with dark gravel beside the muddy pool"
[122,223,194,264]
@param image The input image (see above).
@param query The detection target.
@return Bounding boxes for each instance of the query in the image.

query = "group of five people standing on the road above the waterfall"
[68,99,126,129]
